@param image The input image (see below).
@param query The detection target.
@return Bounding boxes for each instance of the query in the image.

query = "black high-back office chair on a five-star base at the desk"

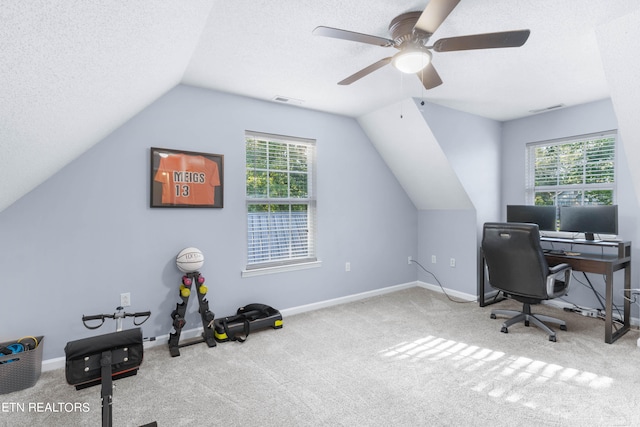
[482,222,571,341]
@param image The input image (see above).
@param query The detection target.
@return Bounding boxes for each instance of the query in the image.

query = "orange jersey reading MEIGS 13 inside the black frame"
[154,154,220,205]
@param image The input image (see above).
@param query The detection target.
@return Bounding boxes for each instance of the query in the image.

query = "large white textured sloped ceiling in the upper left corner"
[0,0,212,210]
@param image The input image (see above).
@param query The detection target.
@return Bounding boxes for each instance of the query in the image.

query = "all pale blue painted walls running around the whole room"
[0,86,640,359]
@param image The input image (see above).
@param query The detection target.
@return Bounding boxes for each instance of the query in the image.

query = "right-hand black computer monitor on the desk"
[560,205,618,240]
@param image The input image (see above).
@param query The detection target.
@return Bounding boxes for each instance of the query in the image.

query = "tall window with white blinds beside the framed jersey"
[245,131,316,270]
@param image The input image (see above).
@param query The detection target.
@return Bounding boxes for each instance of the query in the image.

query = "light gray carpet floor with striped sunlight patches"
[0,288,640,426]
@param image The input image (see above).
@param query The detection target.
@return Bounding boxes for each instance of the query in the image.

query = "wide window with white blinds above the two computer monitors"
[526,131,616,206]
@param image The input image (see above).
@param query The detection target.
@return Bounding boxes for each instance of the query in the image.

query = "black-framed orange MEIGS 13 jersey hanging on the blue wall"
[151,147,224,208]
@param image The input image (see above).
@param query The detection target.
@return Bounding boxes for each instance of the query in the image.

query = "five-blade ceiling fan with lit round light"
[313,0,530,89]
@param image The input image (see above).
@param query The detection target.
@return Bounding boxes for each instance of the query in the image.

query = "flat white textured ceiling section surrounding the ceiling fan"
[183,0,640,121]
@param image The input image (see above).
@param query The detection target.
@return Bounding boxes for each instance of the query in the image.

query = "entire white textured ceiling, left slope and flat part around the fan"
[0,0,640,211]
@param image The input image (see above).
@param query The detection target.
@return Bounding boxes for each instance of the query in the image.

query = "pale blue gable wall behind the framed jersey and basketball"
[0,86,418,359]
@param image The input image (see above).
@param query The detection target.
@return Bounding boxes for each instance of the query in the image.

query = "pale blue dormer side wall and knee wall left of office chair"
[418,103,502,297]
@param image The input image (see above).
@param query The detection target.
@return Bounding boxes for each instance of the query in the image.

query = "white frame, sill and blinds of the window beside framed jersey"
[242,131,320,277]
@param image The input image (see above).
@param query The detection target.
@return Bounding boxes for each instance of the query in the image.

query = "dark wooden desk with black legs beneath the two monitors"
[478,241,631,344]
